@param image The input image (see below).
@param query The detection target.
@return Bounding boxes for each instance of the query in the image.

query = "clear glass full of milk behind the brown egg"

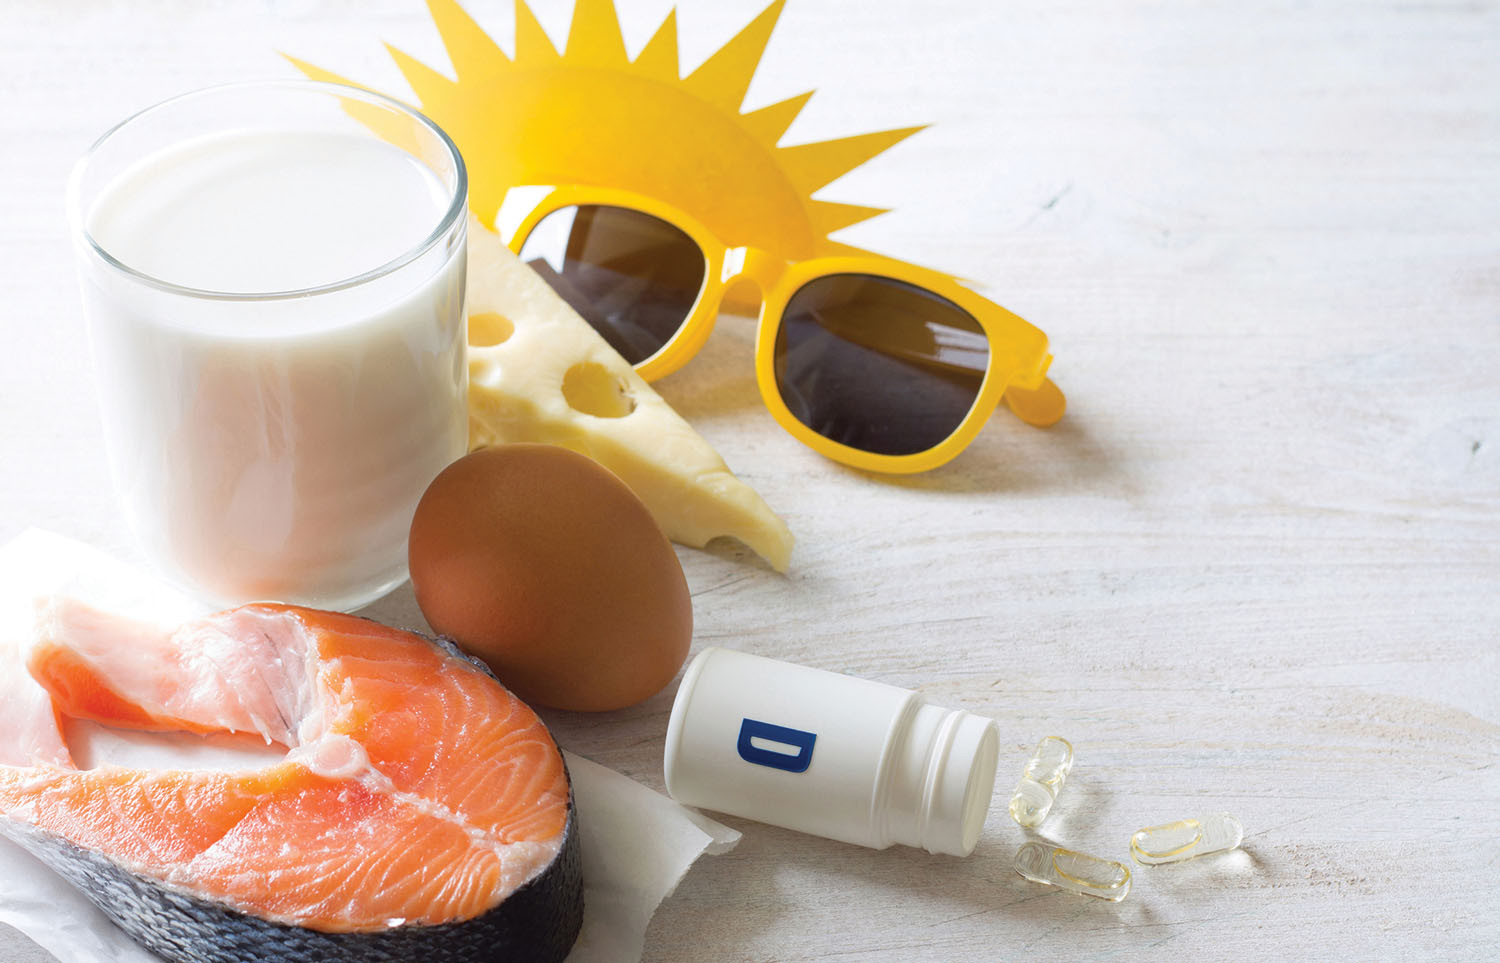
[68,81,468,609]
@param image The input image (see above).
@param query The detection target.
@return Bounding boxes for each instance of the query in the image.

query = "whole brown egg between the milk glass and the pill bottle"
[410,444,693,711]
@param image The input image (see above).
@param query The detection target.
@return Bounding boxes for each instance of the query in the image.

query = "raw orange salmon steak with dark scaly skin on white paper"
[0,599,584,963]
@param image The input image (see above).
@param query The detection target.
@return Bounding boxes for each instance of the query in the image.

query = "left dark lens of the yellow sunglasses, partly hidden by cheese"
[521,204,707,365]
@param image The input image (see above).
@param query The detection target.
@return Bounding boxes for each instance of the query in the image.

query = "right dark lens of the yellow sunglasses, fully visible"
[776,275,990,455]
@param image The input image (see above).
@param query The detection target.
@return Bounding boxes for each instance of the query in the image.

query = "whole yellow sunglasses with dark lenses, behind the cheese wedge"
[506,186,1065,473]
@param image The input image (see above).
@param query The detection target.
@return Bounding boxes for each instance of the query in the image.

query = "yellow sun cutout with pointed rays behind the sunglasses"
[288,0,921,260]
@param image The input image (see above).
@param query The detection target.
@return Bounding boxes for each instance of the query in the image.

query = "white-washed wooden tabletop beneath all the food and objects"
[0,0,1500,963]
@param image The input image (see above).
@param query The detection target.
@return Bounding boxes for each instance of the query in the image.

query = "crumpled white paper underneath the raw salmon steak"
[0,528,740,963]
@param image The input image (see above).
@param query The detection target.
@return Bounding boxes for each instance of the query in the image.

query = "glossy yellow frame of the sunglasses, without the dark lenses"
[497,185,1067,474]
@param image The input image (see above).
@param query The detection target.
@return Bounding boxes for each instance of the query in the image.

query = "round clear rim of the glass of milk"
[68,80,468,302]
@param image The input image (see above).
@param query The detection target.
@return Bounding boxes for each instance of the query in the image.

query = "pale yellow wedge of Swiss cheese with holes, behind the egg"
[468,216,792,572]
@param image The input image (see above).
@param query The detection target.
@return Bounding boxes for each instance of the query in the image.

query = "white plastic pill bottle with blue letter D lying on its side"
[665,648,999,857]
